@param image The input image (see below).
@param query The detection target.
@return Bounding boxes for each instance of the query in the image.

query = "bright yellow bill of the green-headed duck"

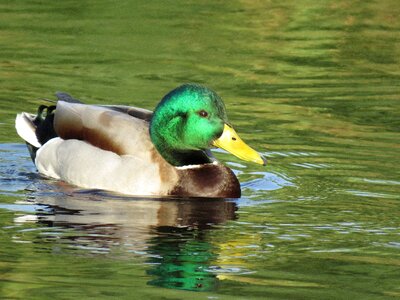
[212,124,267,166]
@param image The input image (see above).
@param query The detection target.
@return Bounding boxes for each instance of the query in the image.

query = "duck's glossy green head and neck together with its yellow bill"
[150,84,265,166]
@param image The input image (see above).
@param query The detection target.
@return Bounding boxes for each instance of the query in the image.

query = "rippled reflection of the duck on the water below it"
[17,184,237,291]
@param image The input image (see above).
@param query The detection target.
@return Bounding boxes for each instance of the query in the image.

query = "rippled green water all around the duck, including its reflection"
[0,0,400,299]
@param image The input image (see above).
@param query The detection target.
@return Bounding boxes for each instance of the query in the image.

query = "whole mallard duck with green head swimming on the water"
[16,84,266,198]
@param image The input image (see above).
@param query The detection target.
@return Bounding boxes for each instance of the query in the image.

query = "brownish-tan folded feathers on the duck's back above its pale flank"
[54,101,154,159]
